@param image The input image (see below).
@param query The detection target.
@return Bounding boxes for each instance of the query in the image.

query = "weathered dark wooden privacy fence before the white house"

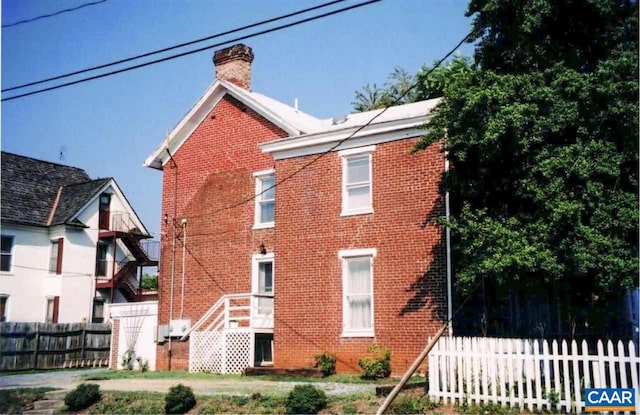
[0,323,111,372]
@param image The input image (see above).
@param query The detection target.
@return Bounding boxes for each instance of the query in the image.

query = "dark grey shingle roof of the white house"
[0,151,109,226]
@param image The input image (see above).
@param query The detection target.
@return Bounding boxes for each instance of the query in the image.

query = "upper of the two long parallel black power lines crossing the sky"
[1,0,346,92]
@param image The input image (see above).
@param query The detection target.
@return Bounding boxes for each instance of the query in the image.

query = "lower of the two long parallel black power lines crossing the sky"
[0,0,382,102]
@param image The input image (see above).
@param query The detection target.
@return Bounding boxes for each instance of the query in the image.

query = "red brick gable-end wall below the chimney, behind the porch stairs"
[156,95,286,370]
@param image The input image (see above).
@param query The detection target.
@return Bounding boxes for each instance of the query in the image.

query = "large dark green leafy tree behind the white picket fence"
[416,0,639,334]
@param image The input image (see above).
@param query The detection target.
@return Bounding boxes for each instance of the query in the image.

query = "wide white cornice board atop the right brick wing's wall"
[260,113,431,160]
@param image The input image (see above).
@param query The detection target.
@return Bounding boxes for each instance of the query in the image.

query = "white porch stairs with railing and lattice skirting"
[186,294,273,373]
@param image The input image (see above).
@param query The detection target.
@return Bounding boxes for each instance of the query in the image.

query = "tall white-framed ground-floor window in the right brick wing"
[338,249,376,337]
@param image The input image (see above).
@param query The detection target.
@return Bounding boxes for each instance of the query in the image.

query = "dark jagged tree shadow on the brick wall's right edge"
[400,195,447,322]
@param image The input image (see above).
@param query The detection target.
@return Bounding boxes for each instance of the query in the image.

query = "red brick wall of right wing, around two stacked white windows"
[274,140,446,374]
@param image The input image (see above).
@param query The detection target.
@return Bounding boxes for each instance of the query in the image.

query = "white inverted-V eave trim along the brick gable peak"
[143,79,302,170]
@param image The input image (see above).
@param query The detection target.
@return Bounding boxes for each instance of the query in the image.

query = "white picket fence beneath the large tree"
[429,337,640,414]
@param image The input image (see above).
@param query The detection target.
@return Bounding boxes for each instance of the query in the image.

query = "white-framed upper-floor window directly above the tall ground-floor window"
[338,146,375,216]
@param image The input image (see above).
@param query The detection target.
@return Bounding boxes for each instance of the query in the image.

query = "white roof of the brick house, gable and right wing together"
[144,79,439,170]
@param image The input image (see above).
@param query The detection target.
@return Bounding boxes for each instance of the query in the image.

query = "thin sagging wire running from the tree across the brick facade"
[182,32,472,223]
